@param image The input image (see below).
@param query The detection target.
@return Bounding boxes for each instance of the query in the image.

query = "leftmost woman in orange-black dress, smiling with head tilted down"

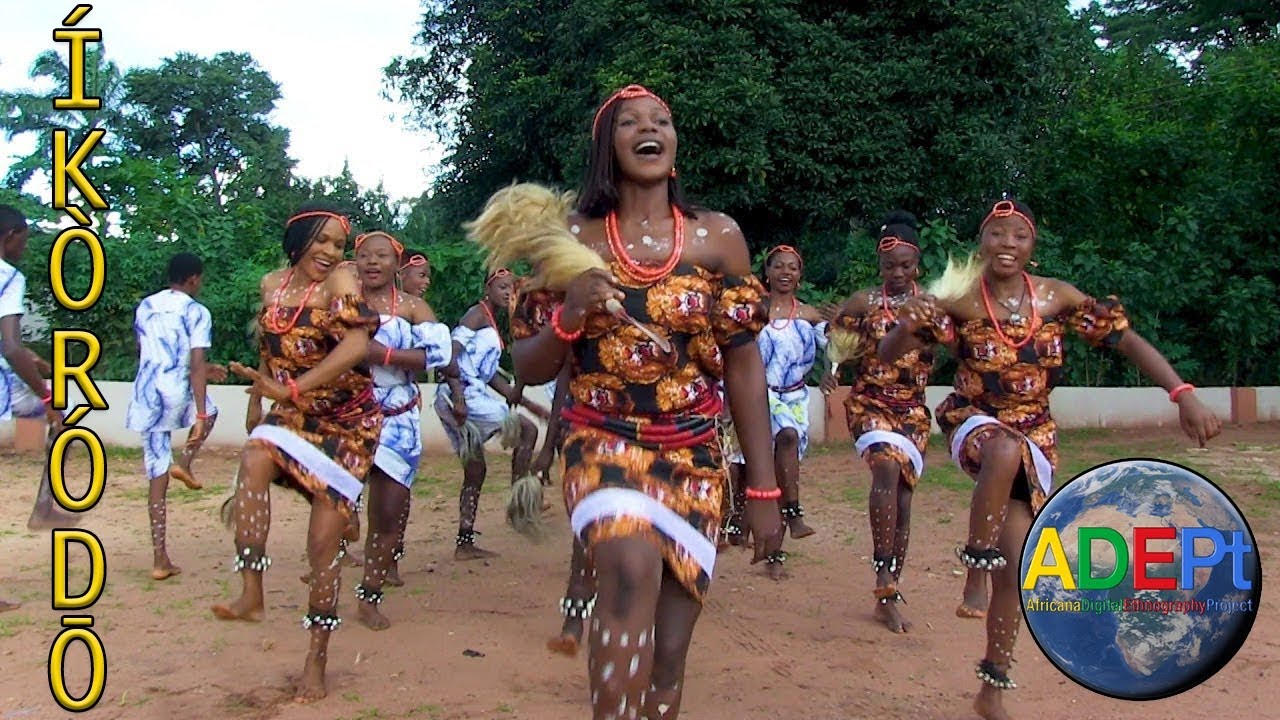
[212,206,383,702]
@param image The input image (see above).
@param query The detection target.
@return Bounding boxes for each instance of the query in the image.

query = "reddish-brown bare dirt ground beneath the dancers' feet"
[0,423,1280,720]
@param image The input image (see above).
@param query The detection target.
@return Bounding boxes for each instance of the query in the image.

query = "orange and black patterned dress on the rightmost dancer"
[937,296,1129,514]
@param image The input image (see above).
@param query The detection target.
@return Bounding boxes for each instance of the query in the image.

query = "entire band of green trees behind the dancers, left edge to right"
[0,0,1280,384]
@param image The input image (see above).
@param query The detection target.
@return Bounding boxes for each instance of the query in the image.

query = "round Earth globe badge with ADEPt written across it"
[1020,459,1262,700]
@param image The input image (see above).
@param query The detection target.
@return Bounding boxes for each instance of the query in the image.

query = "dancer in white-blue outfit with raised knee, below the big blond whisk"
[435,269,547,560]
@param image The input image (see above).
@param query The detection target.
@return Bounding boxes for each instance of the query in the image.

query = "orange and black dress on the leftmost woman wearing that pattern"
[250,296,383,515]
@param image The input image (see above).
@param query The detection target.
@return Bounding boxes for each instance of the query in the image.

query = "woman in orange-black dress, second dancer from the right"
[823,213,934,633]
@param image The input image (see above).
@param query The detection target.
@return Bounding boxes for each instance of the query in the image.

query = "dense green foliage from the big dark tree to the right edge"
[387,0,1280,384]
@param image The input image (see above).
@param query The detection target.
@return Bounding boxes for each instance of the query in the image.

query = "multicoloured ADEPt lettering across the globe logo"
[1023,525,1257,591]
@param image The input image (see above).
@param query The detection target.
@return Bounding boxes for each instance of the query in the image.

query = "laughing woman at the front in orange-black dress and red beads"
[512,86,782,720]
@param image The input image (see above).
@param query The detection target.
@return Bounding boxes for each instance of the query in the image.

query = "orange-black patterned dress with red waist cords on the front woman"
[512,263,768,601]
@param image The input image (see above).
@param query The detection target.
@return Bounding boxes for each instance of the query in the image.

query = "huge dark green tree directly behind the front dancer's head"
[387,0,1091,284]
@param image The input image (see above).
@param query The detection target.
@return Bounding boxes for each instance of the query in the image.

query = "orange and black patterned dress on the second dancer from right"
[836,296,952,487]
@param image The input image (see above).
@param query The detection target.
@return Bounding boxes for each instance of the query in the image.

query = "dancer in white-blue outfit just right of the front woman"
[756,245,827,579]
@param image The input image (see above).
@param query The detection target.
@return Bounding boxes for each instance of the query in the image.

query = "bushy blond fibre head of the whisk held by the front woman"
[462,182,609,291]
